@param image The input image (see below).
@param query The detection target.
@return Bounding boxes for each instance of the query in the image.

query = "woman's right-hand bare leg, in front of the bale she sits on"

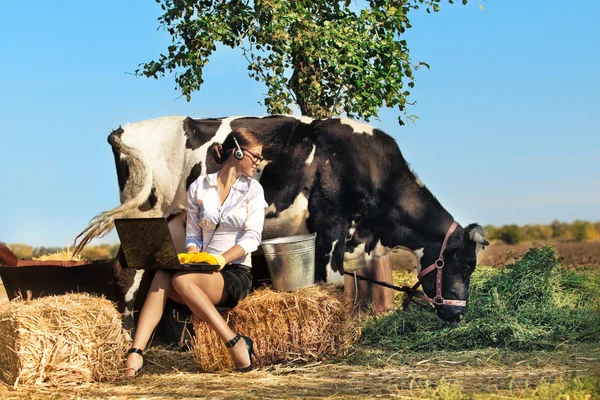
[171,272,250,368]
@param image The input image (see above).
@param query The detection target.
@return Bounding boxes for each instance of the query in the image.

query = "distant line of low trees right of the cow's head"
[484,220,600,244]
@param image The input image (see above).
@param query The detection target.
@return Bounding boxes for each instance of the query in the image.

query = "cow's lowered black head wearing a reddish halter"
[421,224,489,322]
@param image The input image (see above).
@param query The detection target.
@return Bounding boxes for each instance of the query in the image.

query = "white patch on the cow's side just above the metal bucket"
[263,193,308,239]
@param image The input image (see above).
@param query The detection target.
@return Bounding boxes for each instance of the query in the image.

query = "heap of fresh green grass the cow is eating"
[361,246,600,351]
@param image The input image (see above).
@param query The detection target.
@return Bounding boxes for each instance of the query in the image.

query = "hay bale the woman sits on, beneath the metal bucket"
[192,284,360,371]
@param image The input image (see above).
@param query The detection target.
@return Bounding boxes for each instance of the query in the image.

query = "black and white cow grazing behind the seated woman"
[79,116,487,321]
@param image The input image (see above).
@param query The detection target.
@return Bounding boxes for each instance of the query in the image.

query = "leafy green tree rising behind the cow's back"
[136,0,467,125]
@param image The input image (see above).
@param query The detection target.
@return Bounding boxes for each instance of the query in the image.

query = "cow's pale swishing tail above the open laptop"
[73,133,154,254]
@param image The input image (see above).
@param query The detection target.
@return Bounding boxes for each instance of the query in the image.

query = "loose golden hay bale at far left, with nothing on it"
[0,293,128,387]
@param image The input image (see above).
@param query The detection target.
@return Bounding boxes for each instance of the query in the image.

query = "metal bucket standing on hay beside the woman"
[262,233,317,291]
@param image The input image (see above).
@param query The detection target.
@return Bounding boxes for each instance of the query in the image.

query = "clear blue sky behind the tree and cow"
[0,0,600,246]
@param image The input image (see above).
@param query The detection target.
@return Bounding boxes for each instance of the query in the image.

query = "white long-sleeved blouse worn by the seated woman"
[185,173,268,266]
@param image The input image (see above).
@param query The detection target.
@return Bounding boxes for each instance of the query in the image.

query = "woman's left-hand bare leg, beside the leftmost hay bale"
[125,271,179,376]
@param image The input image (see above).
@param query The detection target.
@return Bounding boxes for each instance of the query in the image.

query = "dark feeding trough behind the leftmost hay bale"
[0,243,117,302]
